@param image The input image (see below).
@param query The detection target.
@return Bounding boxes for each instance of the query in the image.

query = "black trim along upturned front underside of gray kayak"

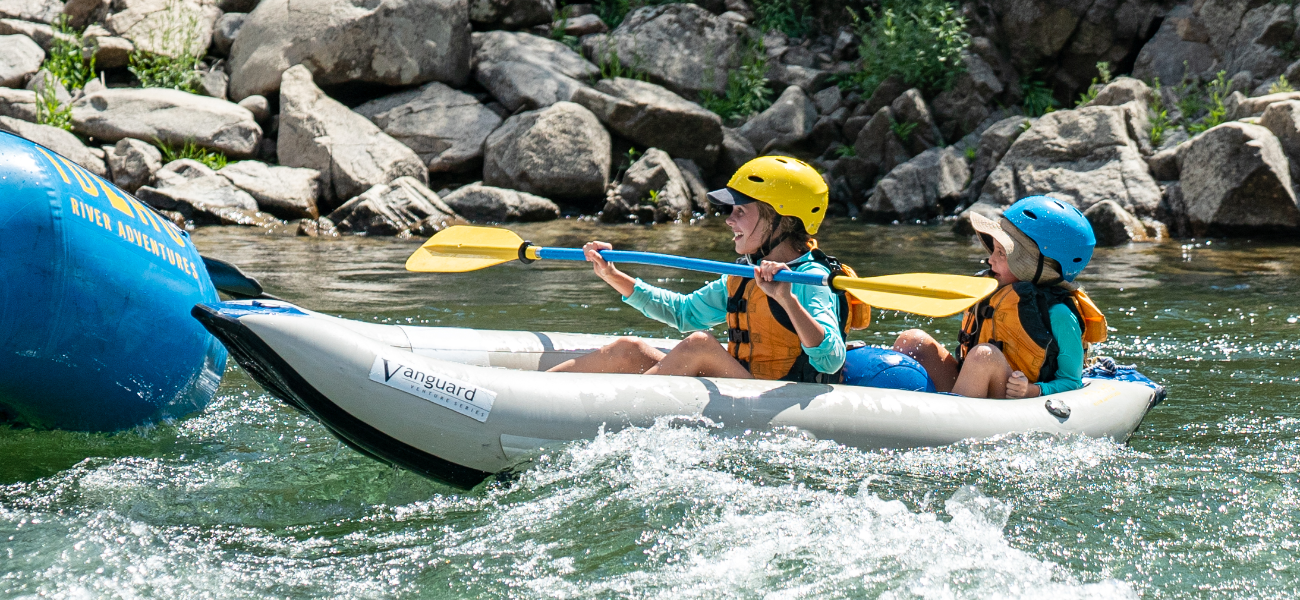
[190,304,491,490]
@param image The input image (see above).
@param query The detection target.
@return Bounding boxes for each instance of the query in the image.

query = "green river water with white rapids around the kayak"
[0,219,1300,600]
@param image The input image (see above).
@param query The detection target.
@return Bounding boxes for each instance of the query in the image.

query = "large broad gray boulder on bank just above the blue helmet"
[979,103,1161,216]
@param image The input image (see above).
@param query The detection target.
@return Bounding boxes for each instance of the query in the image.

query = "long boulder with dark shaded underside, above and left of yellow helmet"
[573,77,723,169]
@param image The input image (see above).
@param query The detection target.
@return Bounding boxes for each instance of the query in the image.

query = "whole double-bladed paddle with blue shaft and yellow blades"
[406,225,997,317]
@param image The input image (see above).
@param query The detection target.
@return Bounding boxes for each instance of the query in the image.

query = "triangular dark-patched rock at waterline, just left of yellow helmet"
[601,148,694,223]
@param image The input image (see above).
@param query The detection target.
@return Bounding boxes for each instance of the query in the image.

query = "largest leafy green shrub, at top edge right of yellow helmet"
[840,0,971,94]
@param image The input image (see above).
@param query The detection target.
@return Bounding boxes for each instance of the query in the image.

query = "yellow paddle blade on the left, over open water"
[407,225,524,273]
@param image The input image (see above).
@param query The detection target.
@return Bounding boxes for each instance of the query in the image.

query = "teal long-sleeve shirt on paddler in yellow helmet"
[623,255,845,373]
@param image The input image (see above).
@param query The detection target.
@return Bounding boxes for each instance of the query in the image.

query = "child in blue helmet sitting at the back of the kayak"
[894,196,1106,397]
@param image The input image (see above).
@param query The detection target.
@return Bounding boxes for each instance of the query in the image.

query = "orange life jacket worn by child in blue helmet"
[957,282,1106,383]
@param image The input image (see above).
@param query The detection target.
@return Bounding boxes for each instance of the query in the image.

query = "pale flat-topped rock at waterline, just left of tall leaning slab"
[217,161,321,221]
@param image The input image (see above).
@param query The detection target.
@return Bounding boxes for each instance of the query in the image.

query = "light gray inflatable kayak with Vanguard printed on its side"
[192,300,1162,487]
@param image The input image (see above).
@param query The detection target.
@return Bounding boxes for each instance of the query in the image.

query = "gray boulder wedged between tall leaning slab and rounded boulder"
[355,82,502,173]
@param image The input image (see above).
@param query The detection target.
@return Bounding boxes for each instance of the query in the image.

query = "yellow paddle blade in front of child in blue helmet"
[835,273,997,317]
